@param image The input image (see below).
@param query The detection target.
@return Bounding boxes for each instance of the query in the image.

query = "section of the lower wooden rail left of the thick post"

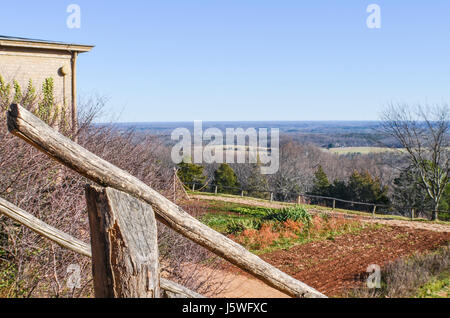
[0,198,91,256]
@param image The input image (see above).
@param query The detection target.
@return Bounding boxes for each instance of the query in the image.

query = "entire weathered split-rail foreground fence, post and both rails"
[0,104,325,298]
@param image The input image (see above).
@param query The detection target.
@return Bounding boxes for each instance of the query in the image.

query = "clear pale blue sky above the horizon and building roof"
[0,0,450,122]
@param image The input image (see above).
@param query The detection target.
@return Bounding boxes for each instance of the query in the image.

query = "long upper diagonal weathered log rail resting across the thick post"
[8,104,325,297]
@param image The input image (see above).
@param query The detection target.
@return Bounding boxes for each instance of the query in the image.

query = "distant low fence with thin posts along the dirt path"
[179,182,450,221]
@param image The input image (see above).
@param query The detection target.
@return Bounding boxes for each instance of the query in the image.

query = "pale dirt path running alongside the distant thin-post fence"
[191,195,450,233]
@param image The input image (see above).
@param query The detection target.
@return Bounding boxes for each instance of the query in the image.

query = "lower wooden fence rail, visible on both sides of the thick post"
[0,194,204,298]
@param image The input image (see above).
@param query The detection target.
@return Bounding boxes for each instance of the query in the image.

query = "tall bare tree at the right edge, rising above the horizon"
[381,104,450,220]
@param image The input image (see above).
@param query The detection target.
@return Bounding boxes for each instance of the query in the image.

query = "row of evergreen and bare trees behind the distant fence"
[179,105,450,220]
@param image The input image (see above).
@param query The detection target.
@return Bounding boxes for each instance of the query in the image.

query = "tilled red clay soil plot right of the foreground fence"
[262,227,450,297]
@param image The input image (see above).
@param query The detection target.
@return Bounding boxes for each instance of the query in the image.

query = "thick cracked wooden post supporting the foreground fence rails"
[86,185,160,298]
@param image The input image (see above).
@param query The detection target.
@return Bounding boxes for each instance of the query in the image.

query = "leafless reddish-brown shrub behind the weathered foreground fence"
[0,91,230,297]
